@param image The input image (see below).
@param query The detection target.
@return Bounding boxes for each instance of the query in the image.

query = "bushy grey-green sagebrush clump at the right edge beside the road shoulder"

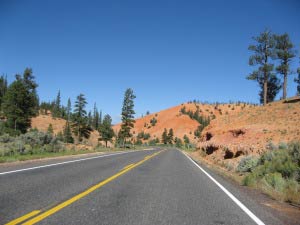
[237,142,300,204]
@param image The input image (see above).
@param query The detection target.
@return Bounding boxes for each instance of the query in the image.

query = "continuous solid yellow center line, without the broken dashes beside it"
[18,151,162,225]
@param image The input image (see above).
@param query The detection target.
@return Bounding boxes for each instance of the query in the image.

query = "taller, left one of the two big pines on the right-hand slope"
[247,30,275,105]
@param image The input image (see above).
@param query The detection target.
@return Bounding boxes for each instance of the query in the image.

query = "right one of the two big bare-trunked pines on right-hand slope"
[275,33,296,99]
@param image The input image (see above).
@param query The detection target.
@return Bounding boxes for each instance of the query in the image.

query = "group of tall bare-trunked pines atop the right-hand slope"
[247,30,300,105]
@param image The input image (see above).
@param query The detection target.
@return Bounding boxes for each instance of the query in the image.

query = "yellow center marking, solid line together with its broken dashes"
[6,151,162,225]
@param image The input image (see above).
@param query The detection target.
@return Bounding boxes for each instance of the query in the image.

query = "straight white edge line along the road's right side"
[180,151,265,225]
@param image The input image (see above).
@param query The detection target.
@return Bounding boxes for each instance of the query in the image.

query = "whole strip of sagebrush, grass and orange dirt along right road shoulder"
[191,142,300,205]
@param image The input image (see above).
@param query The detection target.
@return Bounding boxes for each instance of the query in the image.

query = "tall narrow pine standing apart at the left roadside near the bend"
[119,88,136,146]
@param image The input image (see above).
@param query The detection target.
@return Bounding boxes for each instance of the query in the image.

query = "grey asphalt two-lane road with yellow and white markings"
[0,149,292,225]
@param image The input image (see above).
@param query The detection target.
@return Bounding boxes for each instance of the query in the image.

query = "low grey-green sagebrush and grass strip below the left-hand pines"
[0,129,146,163]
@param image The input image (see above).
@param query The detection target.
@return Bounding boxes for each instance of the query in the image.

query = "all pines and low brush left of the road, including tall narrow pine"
[0,68,142,162]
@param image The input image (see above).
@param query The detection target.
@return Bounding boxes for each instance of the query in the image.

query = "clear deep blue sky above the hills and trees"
[0,0,300,122]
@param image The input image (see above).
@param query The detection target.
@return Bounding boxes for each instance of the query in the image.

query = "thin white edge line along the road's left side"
[0,149,154,176]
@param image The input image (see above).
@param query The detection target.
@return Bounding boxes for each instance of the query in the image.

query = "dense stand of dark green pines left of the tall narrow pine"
[0,68,115,146]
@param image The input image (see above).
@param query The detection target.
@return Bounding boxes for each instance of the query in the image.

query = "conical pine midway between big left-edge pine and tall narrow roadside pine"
[72,94,92,141]
